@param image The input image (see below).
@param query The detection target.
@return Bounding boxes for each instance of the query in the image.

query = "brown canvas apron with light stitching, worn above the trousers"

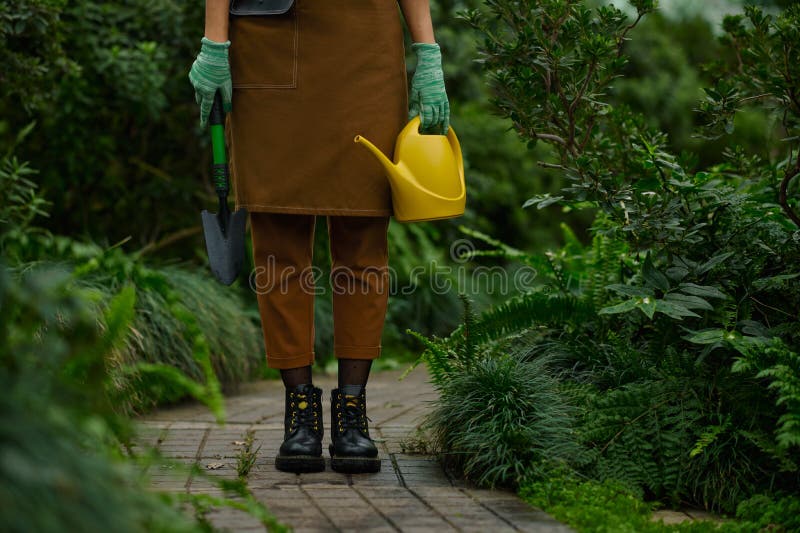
[227,0,408,216]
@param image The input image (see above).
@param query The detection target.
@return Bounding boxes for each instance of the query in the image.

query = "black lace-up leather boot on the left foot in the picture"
[275,383,325,473]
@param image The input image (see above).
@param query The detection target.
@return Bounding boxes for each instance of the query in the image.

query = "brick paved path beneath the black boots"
[140,365,571,533]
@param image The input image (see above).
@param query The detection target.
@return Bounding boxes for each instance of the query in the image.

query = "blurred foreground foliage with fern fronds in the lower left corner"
[0,250,286,531]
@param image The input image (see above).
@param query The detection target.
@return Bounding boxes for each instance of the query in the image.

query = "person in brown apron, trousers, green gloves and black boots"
[189,0,450,473]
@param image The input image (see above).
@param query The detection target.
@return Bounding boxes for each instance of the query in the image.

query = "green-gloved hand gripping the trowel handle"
[189,37,233,128]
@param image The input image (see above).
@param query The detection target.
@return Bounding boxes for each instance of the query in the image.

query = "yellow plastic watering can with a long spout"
[355,115,467,222]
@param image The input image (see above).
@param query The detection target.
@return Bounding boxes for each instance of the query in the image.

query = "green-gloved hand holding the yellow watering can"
[408,43,450,135]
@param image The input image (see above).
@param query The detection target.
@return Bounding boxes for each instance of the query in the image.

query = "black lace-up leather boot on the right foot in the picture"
[328,388,381,473]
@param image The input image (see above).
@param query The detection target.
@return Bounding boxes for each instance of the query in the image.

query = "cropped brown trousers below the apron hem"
[249,212,390,368]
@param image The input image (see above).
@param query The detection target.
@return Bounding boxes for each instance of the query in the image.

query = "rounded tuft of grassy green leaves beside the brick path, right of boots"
[424,348,579,486]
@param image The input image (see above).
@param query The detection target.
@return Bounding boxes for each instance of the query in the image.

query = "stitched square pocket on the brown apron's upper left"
[229,2,299,89]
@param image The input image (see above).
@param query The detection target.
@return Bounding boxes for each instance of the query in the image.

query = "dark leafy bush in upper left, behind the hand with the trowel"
[0,0,203,246]
